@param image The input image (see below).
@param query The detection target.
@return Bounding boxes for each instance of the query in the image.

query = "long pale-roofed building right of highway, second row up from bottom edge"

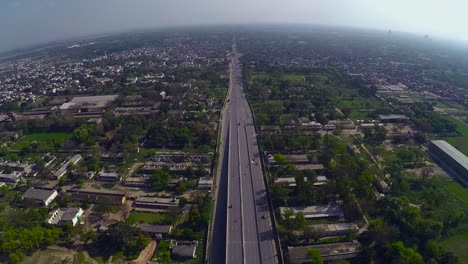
[280,203,344,219]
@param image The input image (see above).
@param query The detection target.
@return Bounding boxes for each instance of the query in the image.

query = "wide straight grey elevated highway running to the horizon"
[209,41,278,264]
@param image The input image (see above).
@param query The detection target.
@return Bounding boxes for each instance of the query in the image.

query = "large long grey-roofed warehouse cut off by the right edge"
[429,140,468,186]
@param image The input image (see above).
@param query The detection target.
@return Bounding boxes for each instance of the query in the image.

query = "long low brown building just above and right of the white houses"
[67,189,127,205]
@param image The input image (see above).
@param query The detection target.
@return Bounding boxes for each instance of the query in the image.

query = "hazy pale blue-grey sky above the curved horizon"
[0,0,468,50]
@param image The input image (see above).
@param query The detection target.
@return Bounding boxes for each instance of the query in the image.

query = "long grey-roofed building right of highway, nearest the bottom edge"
[288,241,362,263]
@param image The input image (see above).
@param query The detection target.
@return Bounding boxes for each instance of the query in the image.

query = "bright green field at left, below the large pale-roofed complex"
[12,133,72,150]
